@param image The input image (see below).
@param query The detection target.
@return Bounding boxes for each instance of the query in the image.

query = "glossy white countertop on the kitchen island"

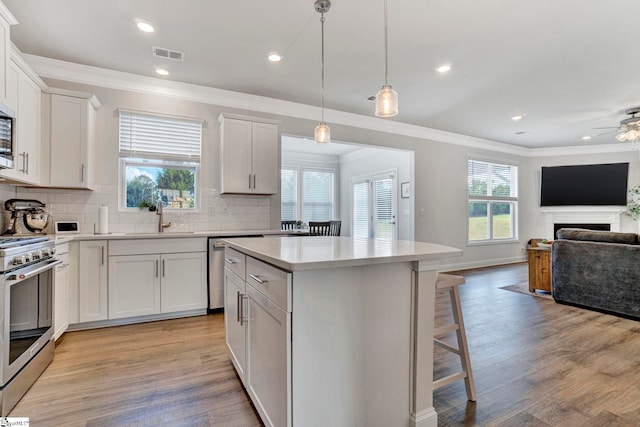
[224,236,462,271]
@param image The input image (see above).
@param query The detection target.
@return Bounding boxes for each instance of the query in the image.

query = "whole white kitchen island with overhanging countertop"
[225,237,462,427]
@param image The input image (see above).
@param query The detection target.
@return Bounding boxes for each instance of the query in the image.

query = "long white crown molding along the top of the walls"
[21,54,630,157]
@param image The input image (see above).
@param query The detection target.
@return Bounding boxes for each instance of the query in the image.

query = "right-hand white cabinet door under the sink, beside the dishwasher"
[161,252,207,313]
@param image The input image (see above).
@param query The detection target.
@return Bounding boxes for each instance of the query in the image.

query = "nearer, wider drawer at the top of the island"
[246,257,291,311]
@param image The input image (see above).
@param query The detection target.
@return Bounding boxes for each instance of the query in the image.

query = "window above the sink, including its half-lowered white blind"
[120,110,202,209]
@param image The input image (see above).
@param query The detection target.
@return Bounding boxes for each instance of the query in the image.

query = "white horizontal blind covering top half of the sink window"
[119,110,202,162]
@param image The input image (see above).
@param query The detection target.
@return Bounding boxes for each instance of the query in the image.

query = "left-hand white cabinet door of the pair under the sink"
[109,255,160,319]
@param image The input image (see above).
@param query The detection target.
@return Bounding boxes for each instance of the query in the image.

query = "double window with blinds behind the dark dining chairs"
[280,166,336,222]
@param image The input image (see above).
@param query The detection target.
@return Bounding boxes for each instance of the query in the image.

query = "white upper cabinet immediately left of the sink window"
[49,89,100,190]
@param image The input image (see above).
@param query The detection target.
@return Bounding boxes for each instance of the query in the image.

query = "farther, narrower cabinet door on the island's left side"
[224,268,246,384]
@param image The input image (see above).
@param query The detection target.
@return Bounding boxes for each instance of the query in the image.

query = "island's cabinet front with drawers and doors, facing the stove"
[225,248,292,426]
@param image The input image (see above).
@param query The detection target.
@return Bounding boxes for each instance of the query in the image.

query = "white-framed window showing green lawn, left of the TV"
[467,160,518,242]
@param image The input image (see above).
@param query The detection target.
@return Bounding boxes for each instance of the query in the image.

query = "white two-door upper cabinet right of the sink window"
[219,113,280,194]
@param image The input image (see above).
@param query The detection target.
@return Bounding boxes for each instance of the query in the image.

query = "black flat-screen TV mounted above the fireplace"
[540,163,629,206]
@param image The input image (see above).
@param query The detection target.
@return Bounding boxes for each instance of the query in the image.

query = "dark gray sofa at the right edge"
[551,228,640,320]
